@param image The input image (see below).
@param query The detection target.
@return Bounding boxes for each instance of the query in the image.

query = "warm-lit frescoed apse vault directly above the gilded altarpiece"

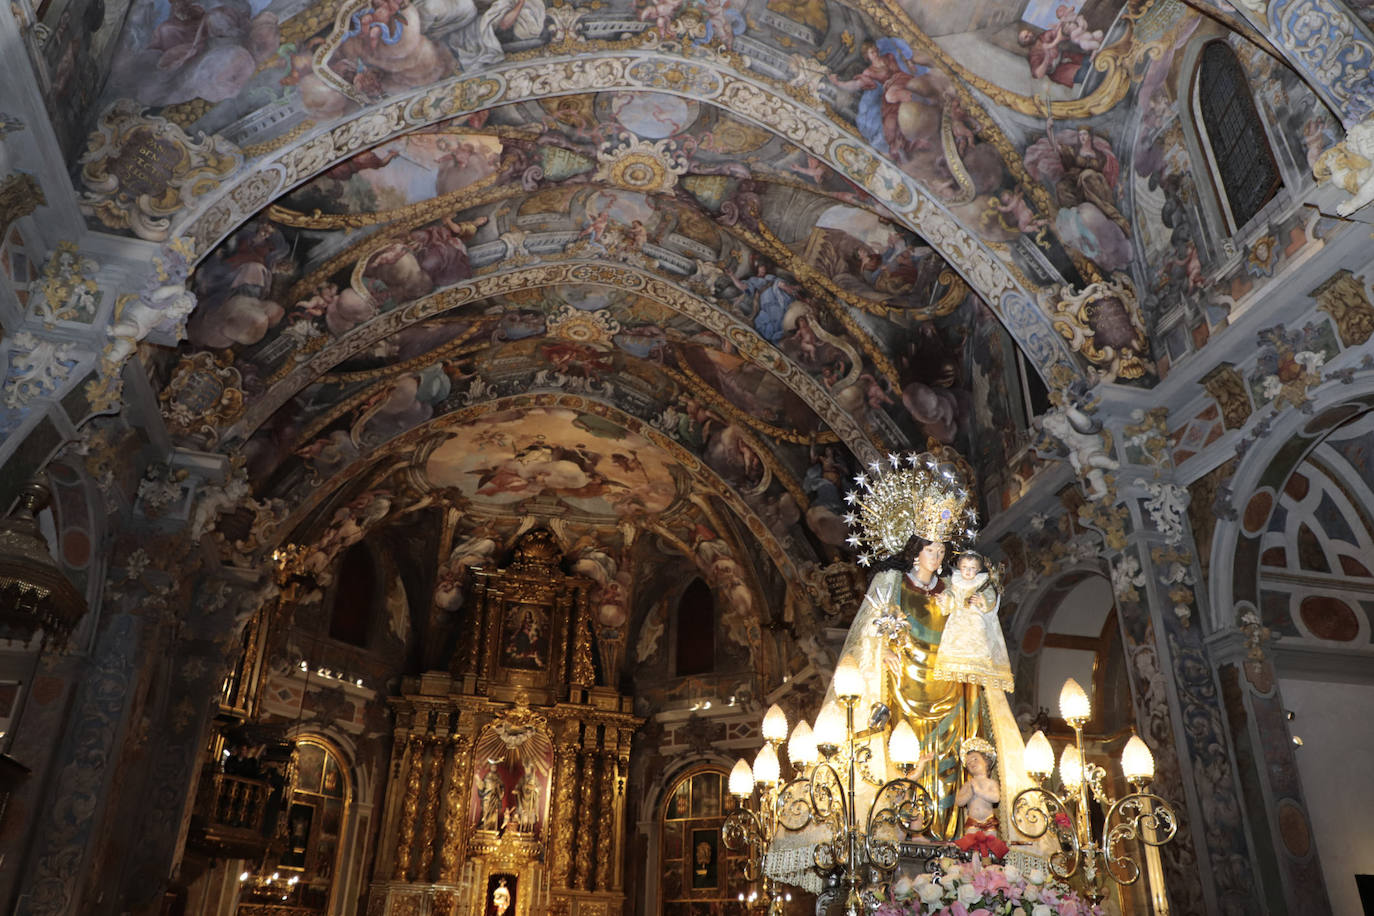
[278,394,797,669]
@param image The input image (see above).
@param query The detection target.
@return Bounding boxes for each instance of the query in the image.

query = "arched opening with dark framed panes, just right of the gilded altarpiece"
[658,768,746,916]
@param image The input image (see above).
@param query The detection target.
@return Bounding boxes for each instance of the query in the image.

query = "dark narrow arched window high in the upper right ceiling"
[1193,41,1283,232]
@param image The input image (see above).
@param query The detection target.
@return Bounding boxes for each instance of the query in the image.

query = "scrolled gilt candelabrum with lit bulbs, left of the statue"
[725,658,934,916]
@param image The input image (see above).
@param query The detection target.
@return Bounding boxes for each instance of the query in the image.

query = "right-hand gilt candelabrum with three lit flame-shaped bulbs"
[1011,677,1178,912]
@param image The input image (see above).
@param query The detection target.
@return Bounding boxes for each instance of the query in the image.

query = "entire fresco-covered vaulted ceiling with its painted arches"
[5,0,1357,667]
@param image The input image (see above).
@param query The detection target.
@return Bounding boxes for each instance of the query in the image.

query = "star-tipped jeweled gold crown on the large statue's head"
[845,452,978,566]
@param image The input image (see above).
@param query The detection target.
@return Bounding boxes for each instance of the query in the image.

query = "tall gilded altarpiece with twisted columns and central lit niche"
[368,530,642,916]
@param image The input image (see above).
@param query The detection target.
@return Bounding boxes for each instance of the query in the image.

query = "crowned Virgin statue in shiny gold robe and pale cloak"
[765,453,1029,891]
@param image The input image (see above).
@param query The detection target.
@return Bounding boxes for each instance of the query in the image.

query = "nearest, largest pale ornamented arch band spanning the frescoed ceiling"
[173,48,1083,387]
